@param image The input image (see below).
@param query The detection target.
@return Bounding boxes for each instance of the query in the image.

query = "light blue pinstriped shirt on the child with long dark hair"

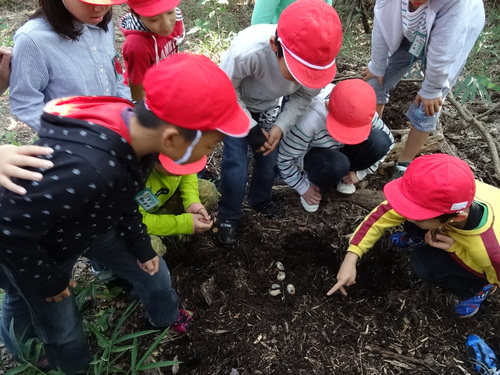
[10,18,130,131]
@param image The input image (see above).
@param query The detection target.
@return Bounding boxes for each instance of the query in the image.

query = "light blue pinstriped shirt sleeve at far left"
[9,33,49,131]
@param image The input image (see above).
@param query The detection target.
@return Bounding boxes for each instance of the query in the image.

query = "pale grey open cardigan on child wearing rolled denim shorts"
[368,0,485,99]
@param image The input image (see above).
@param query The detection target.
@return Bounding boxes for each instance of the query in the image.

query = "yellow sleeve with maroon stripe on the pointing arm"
[347,201,406,258]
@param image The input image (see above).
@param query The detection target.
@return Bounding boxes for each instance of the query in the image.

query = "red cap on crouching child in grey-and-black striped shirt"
[326,79,377,145]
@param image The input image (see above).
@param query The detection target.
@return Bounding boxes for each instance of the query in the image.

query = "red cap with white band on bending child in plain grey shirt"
[278,0,342,89]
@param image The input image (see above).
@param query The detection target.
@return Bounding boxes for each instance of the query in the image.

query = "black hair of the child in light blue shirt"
[29,0,113,40]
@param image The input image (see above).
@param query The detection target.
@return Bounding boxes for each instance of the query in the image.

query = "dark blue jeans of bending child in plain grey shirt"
[219,135,278,220]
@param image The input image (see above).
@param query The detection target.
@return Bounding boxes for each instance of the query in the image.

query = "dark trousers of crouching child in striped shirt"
[304,129,391,195]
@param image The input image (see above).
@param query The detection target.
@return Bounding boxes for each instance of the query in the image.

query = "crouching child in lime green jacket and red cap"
[139,155,217,256]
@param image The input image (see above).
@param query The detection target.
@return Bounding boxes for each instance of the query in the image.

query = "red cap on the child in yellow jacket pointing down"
[384,154,476,220]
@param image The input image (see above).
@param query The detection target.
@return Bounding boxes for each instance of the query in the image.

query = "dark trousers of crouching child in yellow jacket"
[410,244,488,300]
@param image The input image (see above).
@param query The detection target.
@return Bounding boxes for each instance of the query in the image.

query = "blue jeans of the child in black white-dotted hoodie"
[0,230,179,374]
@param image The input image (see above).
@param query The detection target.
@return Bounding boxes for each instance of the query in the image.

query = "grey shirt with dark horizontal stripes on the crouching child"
[278,84,394,195]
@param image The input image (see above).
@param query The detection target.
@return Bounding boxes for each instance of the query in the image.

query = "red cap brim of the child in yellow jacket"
[384,177,443,220]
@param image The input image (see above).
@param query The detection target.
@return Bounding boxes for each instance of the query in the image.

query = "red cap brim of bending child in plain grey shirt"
[283,52,337,89]
